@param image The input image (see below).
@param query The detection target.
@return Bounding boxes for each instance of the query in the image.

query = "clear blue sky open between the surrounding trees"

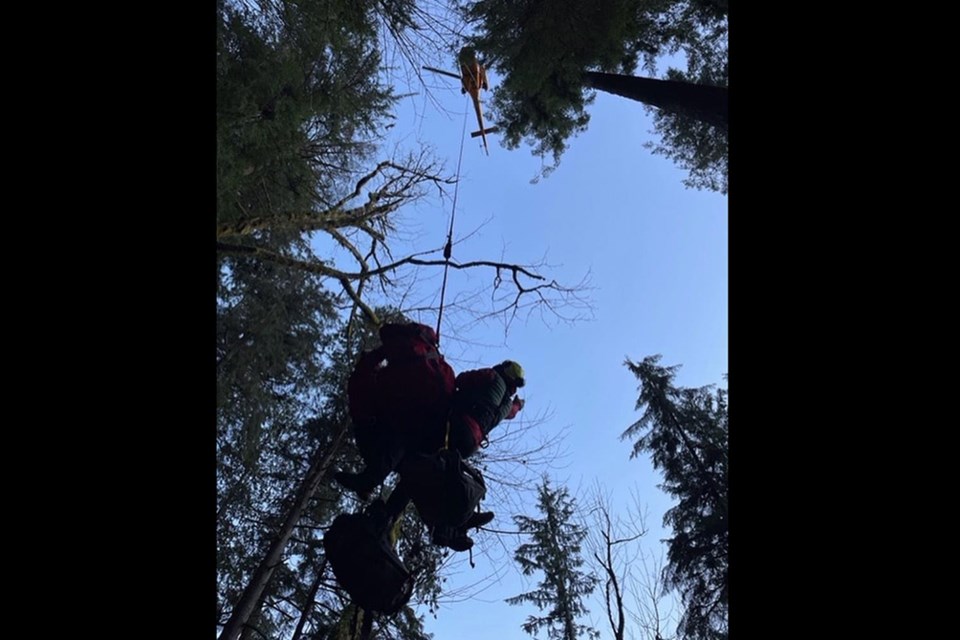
[318,57,728,639]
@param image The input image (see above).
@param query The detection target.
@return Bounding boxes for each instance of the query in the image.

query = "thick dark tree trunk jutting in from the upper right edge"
[586,71,728,131]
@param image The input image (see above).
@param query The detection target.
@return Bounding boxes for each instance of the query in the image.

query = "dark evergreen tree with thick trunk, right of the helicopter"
[461,0,727,192]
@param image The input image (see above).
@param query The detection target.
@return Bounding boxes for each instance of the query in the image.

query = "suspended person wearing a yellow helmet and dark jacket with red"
[433,360,526,551]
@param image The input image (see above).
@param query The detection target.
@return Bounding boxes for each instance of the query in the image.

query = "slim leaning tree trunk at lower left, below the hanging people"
[219,424,347,640]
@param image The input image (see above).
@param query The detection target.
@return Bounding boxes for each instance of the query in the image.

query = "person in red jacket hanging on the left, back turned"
[334,322,455,502]
